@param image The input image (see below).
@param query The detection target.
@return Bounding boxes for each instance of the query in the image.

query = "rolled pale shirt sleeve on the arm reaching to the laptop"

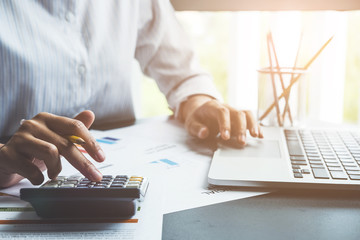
[135,0,222,116]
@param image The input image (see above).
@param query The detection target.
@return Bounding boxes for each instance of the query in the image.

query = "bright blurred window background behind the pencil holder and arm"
[137,2,360,123]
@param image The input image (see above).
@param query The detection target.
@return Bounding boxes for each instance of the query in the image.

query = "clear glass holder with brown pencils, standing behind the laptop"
[257,67,307,127]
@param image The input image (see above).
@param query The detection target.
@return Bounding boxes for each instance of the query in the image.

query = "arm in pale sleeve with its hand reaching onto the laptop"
[136,0,263,145]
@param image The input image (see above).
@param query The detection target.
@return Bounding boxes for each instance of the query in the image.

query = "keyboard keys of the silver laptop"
[284,129,360,180]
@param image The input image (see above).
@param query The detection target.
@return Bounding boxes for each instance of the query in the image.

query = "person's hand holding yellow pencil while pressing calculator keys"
[0,111,105,187]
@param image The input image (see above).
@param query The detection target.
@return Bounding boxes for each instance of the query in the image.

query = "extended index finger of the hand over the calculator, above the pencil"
[34,113,105,162]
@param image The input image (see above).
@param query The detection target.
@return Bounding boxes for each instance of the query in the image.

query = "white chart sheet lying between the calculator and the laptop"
[85,119,265,214]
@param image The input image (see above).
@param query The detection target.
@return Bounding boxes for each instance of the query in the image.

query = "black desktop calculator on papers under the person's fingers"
[20,175,149,219]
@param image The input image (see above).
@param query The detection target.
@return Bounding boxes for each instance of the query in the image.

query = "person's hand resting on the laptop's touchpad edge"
[180,95,263,145]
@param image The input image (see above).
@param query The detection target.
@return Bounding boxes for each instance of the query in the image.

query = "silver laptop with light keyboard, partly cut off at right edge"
[208,127,360,190]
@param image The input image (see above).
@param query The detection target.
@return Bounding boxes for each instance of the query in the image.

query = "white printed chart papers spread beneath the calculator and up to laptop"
[0,118,264,239]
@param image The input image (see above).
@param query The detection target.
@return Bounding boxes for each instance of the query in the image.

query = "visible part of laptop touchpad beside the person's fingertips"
[220,139,281,158]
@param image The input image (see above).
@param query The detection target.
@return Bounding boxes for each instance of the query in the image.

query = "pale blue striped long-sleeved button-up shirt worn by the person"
[0,0,220,136]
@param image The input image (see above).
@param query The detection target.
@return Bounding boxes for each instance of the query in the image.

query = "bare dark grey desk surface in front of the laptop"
[162,183,360,240]
